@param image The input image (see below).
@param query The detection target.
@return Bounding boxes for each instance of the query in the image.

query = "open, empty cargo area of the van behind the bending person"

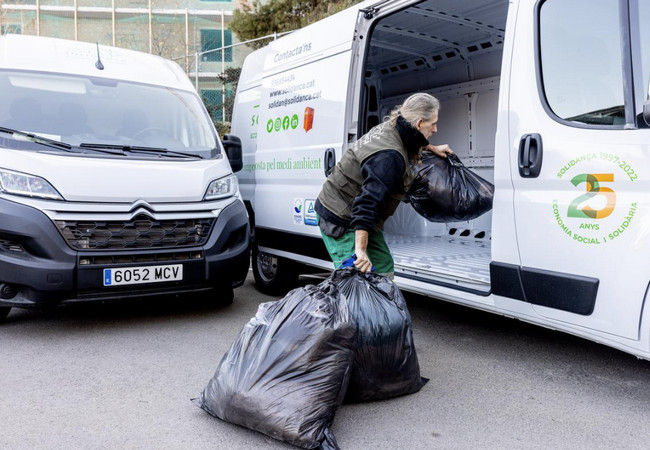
[359,0,508,294]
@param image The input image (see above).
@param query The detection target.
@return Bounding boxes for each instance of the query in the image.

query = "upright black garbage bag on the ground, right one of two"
[326,268,425,402]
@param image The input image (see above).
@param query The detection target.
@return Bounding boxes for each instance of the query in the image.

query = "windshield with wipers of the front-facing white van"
[0,71,221,158]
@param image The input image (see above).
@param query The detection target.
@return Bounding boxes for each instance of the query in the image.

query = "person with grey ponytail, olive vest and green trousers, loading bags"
[315,93,453,278]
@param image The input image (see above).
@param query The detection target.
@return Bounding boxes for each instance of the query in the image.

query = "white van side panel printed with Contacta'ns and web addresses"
[232,10,357,236]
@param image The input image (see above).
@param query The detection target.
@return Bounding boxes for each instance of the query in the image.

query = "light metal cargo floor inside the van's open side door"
[384,233,492,292]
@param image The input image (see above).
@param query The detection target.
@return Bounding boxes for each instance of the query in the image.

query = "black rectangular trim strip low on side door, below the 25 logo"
[490,261,600,316]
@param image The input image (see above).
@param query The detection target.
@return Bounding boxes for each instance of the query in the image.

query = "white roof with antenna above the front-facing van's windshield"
[0,34,194,90]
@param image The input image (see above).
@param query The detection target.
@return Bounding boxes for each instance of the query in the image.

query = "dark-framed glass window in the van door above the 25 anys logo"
[539,0,625,126]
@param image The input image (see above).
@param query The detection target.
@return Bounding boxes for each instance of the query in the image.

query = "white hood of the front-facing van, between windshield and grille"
[0,149,232,203]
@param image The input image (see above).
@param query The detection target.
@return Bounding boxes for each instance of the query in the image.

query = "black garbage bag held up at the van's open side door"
[406,152,494,222]
